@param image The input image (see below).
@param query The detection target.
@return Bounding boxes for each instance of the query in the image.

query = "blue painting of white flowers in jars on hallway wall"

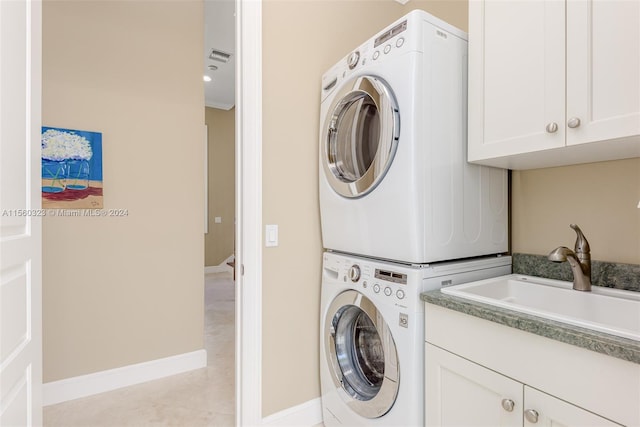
[41,126,103,209]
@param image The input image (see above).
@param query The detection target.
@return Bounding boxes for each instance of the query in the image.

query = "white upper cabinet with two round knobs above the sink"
[468,0,640,169]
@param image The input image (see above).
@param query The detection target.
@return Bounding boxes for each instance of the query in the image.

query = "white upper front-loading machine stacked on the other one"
[319,10,507,263]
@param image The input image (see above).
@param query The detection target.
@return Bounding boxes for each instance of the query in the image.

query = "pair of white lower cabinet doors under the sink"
[425,343,620,427]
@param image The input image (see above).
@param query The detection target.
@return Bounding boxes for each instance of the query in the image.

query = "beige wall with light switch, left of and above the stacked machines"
[262,0,467,416]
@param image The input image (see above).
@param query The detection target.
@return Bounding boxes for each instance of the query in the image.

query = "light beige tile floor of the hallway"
[44,273,235,427]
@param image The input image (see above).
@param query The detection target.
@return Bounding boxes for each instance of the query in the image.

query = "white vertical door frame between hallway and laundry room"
[235,0,262,426]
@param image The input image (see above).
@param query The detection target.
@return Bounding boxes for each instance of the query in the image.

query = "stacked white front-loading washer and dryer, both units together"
[319,10,511,426]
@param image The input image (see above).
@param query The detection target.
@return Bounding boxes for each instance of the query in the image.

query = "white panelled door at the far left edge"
[0,0,42,426]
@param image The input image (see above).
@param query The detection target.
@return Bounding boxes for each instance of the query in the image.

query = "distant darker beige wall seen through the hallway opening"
[204,108,236,266]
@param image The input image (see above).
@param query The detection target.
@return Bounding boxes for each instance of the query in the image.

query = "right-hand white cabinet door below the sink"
[524,386,620,427]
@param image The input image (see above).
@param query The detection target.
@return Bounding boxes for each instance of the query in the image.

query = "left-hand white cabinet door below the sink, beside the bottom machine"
[425,343,523,427]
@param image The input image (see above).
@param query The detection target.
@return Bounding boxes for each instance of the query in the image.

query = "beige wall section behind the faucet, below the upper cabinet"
[511,159,640,264]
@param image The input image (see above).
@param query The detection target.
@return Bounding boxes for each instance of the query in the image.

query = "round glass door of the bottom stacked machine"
[325,290,400,418]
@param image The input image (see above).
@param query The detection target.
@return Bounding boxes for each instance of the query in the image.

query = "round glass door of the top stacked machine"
[320,76,400,198]
